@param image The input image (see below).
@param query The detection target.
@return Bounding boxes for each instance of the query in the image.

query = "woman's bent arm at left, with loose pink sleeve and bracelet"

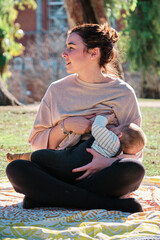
[28,90,93,151]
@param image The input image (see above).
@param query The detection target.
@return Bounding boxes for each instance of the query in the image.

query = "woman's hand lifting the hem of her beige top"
[64,114,95,135]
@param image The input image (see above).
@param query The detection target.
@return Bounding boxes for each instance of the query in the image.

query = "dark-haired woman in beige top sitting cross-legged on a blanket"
[6,24,144,212]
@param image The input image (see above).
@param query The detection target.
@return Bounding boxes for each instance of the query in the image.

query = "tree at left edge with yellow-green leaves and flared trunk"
[0,0,36,105]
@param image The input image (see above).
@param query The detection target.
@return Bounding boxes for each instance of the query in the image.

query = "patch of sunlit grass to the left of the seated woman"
[0,107,37,178]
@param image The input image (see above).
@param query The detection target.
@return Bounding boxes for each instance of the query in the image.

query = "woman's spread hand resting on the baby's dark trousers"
[72,148,118,180]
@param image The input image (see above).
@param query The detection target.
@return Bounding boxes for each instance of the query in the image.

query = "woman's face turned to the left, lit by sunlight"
[62,33,91,74]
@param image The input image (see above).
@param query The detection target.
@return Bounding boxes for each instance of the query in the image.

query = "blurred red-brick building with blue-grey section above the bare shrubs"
[17,0,68,45]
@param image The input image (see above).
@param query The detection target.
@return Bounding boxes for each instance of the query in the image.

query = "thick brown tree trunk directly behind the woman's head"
[64,0,124,79]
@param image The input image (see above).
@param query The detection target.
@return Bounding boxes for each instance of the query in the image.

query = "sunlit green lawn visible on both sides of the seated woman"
[0,99,160,178]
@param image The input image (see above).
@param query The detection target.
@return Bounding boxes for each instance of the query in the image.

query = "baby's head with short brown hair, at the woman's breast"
[118,123,147,154]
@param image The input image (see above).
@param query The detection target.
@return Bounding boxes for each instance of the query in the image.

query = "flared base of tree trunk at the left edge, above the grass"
[0,76,22,106]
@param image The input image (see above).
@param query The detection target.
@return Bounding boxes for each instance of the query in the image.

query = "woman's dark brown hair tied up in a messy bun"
[68,24,119,74]
